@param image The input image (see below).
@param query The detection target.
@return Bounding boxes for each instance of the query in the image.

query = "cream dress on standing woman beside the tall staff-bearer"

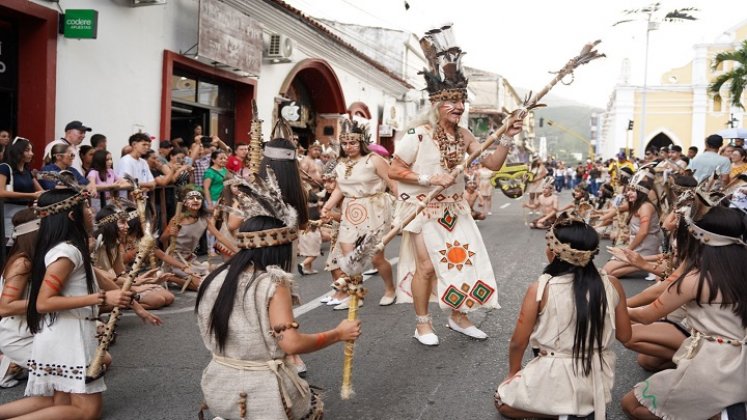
[335,153,392,243]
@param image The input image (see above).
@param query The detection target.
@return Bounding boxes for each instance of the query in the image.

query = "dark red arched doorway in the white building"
[280,58,347,147]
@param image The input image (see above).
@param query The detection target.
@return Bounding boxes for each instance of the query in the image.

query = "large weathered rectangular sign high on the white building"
[197,0,262,76]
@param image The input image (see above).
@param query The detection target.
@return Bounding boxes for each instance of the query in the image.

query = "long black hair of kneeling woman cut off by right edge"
[670,206,747,328]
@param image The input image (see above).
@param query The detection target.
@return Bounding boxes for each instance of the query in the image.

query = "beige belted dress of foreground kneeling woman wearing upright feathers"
[197,266,322,420]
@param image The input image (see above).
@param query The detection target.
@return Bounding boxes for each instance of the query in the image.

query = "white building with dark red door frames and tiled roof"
[0,0,420,163]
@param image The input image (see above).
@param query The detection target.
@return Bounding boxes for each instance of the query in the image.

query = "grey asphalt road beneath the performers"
[0,192,650,420]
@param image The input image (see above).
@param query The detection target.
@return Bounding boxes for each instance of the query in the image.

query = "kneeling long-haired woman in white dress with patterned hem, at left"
[0,189,132,419]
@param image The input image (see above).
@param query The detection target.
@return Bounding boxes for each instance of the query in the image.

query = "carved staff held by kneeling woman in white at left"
[86,183,156,383]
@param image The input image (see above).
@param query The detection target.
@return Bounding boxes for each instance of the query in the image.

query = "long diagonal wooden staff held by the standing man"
[378,41,605,249]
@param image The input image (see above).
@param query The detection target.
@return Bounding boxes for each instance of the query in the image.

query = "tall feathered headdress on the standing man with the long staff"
[419,24,467,102]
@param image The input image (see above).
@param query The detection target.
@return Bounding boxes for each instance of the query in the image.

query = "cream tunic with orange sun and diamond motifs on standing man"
[394,126,500,313]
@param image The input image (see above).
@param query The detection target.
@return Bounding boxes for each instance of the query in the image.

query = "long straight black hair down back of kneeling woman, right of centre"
[543,221,609,376]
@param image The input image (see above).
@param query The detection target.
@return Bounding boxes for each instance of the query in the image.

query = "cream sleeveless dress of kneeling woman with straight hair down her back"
[496,274,620,420]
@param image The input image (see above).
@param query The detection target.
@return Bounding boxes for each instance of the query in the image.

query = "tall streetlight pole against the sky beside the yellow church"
[612,2,698,157]
